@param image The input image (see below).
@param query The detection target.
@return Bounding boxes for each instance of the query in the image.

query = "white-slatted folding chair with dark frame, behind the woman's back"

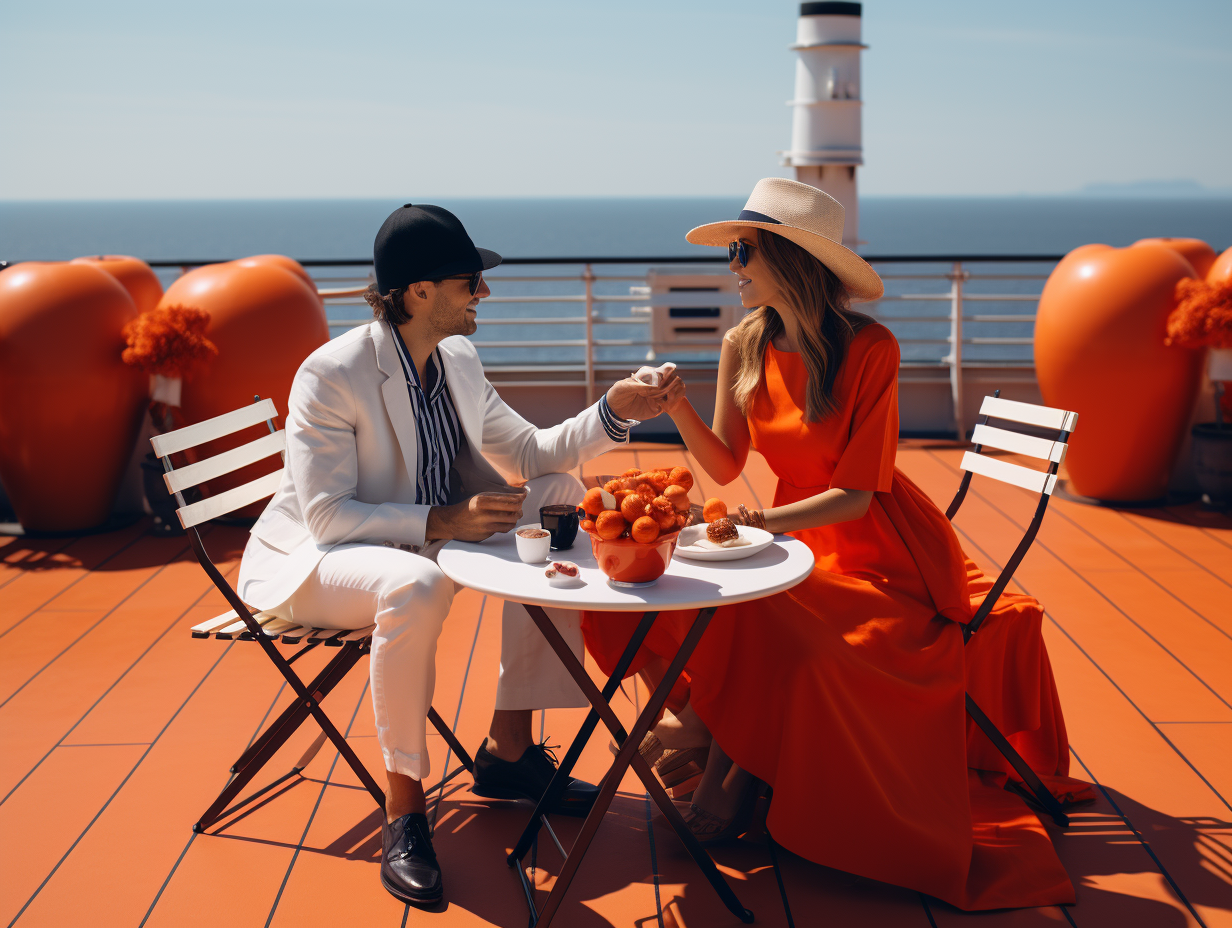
[945,389,1078,827]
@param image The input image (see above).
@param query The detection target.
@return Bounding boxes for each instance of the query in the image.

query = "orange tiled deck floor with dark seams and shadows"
[0,441,1232,928]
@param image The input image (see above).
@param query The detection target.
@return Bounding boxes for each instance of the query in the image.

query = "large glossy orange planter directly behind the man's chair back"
[160,258,329,493]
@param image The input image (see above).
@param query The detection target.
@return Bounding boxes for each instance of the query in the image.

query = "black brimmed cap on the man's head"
[372,203,501,295]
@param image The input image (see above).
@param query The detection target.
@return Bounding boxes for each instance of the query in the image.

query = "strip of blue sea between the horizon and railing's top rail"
[0,197,1232,263]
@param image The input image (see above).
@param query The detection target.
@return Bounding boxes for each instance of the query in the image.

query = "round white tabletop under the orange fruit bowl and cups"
[436,531,813,613]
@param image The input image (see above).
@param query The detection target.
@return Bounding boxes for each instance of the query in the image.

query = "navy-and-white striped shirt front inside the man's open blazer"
[391,325,462,505]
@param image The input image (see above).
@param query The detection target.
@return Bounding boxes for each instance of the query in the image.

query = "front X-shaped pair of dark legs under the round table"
[519,606,753,928]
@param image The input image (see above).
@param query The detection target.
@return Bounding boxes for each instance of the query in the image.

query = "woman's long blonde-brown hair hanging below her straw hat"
[729,229,873,421]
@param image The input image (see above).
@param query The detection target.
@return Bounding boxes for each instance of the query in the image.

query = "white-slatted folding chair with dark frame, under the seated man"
[150,397,473,832]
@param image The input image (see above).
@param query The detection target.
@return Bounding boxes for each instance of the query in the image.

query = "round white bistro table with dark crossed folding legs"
[436,532,813,928]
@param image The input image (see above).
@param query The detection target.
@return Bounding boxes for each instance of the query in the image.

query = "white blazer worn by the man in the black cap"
[238,322,618,609]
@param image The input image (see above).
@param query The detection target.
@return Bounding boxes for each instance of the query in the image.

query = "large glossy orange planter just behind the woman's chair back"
[1035,243,1202,502]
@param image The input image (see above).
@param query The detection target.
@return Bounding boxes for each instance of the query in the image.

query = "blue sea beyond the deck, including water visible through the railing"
[0,197,1232,366]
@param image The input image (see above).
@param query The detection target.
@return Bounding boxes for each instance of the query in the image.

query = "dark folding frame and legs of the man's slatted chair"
[161,397,474,832]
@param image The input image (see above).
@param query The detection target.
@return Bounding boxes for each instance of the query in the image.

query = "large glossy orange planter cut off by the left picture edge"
[0,261,149,531]
